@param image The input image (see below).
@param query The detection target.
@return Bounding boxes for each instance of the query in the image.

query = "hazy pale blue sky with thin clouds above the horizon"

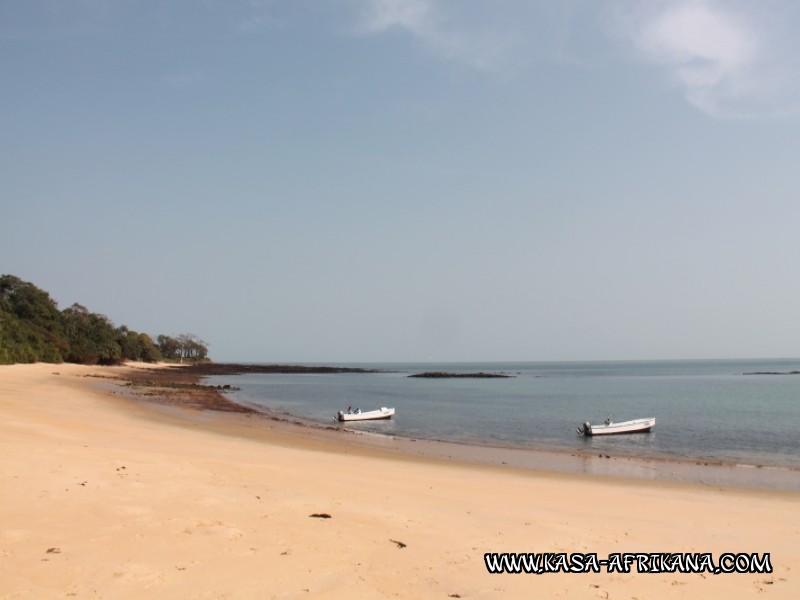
[0,0,800,363]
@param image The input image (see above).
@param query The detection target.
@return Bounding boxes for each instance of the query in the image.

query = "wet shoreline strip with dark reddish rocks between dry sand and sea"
[114,363,800,491]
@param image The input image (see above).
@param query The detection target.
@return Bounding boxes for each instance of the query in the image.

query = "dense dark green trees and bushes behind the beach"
[0,275,208,365]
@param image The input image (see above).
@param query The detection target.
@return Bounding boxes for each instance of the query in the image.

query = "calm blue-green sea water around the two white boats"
[209,359,800,469]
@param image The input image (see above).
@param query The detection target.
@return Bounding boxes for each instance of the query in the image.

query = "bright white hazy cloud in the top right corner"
[617,0,800,118]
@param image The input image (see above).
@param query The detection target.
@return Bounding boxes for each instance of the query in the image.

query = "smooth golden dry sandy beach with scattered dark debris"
[0,364,800,599]
